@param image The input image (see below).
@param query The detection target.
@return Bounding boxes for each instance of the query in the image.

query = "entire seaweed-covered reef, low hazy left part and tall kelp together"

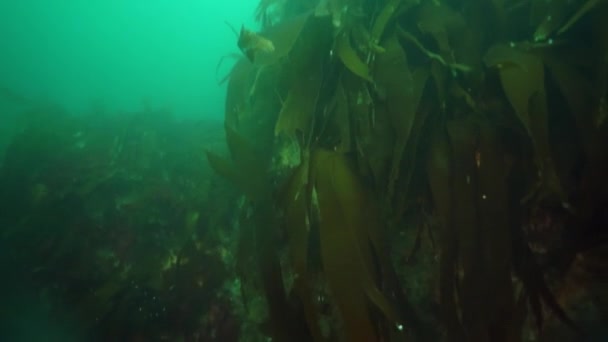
[0,0,608,342]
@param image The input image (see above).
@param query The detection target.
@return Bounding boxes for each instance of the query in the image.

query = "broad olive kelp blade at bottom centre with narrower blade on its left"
[281,150,400,341]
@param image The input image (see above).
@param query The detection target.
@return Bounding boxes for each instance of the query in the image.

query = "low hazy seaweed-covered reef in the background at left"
[0,105,245,341]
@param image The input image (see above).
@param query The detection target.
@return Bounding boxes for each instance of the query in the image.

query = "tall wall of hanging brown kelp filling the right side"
[207,0,608,342]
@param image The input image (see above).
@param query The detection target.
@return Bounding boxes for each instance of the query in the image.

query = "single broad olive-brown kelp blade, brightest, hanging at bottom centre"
[311,150,398,341]
